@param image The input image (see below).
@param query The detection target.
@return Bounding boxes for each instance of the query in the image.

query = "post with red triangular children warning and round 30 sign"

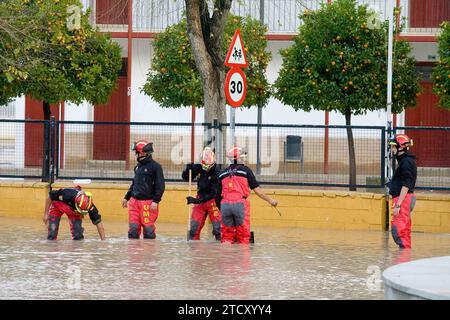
[224,29,248,145]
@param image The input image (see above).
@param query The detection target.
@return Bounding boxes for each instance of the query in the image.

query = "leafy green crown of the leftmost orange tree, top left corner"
[0,0,122,104]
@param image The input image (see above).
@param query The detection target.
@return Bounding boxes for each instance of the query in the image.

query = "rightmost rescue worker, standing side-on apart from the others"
[389,134,417,248]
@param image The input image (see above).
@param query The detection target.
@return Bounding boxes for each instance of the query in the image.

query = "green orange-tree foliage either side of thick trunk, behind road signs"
[142,15,271,108]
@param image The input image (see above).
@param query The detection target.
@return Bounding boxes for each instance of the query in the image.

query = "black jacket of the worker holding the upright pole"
[181,164,220,203]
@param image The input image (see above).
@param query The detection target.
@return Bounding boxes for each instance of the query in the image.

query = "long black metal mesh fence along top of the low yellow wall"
[0,119,450,190]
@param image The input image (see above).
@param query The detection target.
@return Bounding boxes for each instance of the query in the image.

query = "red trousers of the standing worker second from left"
[128,197,159,239]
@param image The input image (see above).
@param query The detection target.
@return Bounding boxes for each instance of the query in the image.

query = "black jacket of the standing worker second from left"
[125,157,165,203]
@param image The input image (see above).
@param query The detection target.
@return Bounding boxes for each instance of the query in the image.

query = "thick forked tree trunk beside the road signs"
[185,0,231,163]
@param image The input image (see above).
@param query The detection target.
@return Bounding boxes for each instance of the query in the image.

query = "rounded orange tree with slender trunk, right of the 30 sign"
[274,0,420,190]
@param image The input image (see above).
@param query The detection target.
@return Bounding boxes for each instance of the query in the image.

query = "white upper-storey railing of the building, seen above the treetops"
[82,0,450,35]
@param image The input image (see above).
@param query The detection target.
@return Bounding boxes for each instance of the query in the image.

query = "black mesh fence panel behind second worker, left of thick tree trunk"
[56,121,209,181]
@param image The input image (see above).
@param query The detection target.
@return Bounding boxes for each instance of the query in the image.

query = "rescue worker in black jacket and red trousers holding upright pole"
[181,147,220,240]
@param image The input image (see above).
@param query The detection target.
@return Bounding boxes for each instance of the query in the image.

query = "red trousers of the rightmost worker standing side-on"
[391,193,416,248]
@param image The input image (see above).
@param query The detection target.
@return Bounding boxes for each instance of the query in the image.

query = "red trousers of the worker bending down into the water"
[47,201,84,240]
